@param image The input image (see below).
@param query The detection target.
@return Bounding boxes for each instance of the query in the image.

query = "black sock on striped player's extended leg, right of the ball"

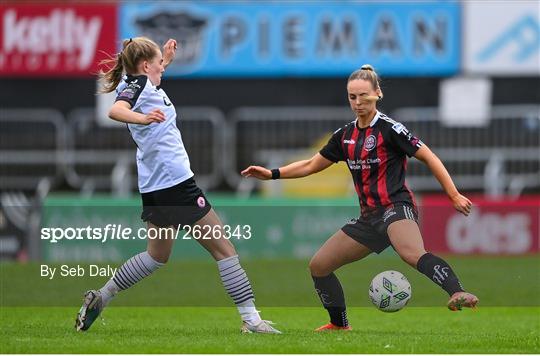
[416,252,464,296]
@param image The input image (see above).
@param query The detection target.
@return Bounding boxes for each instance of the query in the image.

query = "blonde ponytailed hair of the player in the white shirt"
[99,37,160,93]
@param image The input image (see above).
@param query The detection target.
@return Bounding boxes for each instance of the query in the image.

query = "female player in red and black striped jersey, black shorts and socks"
[242,65,478,331]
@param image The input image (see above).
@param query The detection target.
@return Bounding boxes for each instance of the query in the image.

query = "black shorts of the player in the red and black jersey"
[341,204,418,253]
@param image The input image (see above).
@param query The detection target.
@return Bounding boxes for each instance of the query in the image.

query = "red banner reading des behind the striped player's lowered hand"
[420,195,540,255]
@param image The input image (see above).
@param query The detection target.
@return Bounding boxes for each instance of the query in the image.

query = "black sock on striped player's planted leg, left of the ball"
[311,273,349,326]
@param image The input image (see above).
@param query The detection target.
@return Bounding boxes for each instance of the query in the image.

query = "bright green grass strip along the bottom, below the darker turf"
[0,307,540,353]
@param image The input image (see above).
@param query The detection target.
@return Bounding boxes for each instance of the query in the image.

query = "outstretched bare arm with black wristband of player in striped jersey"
[242,153,334,180]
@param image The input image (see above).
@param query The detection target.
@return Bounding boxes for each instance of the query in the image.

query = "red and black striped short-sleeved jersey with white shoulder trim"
[319,111,422,214]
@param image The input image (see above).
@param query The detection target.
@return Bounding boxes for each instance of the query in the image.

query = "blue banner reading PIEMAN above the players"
[119,1,461,77]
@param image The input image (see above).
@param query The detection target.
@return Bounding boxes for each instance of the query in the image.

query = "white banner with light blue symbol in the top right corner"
[463,0,540,76]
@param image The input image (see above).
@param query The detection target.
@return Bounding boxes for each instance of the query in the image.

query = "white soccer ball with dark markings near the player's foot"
[369,271,412,312]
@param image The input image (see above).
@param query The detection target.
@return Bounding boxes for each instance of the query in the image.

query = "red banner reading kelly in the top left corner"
[0,2,118,77]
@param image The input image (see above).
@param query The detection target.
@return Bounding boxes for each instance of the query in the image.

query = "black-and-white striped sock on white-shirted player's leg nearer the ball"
[217,255,261,325]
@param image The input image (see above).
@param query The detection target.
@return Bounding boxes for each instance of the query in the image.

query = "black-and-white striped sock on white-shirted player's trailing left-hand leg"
[99,251,163,306]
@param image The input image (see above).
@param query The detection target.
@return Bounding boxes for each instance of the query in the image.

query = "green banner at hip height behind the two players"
[39,197,359,262]
